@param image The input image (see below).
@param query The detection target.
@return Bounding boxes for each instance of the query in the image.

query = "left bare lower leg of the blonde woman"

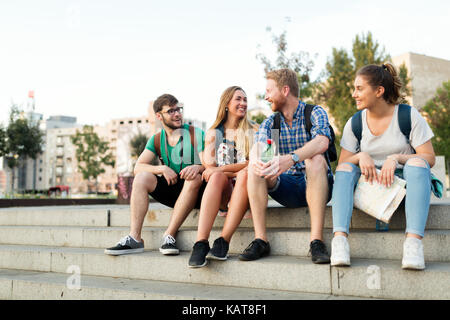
[196,172,229,241]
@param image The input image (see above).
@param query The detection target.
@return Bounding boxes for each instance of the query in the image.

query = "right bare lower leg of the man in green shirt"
[164,175,202,237]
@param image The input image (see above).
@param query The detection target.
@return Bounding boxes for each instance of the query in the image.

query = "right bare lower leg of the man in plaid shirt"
[305,155,328,241]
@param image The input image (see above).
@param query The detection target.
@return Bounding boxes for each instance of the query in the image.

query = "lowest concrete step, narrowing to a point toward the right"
[0,269,368,301]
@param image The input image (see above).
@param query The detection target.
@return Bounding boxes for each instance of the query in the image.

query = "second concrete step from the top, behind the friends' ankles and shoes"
[0,226,450,262]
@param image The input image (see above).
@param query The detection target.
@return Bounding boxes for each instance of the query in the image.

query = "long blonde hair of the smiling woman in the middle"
[210,86,254,160]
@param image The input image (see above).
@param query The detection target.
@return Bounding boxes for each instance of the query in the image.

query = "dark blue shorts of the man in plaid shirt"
[268,170,334,208]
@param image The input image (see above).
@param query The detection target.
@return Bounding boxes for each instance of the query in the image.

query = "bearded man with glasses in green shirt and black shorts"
[105,94,205,255]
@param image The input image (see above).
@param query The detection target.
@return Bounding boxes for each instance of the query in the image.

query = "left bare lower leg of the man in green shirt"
[130,172,157,241]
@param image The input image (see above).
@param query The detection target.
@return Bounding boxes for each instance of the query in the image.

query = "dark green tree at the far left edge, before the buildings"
[3,103,44,191]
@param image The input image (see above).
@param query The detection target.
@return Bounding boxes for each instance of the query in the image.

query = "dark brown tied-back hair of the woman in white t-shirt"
[356,62,403,104]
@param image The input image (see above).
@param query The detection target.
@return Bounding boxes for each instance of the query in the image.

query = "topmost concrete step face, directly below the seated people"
[0,201,450,230]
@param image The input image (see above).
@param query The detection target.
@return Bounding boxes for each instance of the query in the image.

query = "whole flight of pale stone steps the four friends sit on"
[0,201,450,300]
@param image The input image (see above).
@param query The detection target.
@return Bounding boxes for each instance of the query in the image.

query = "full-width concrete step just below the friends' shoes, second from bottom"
[0,245,450,299]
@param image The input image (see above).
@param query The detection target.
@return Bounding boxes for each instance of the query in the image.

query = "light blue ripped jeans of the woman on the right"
[331,158,431,237]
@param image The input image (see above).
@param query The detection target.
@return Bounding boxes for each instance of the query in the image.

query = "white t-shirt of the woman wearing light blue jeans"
[341,105,434,168]
